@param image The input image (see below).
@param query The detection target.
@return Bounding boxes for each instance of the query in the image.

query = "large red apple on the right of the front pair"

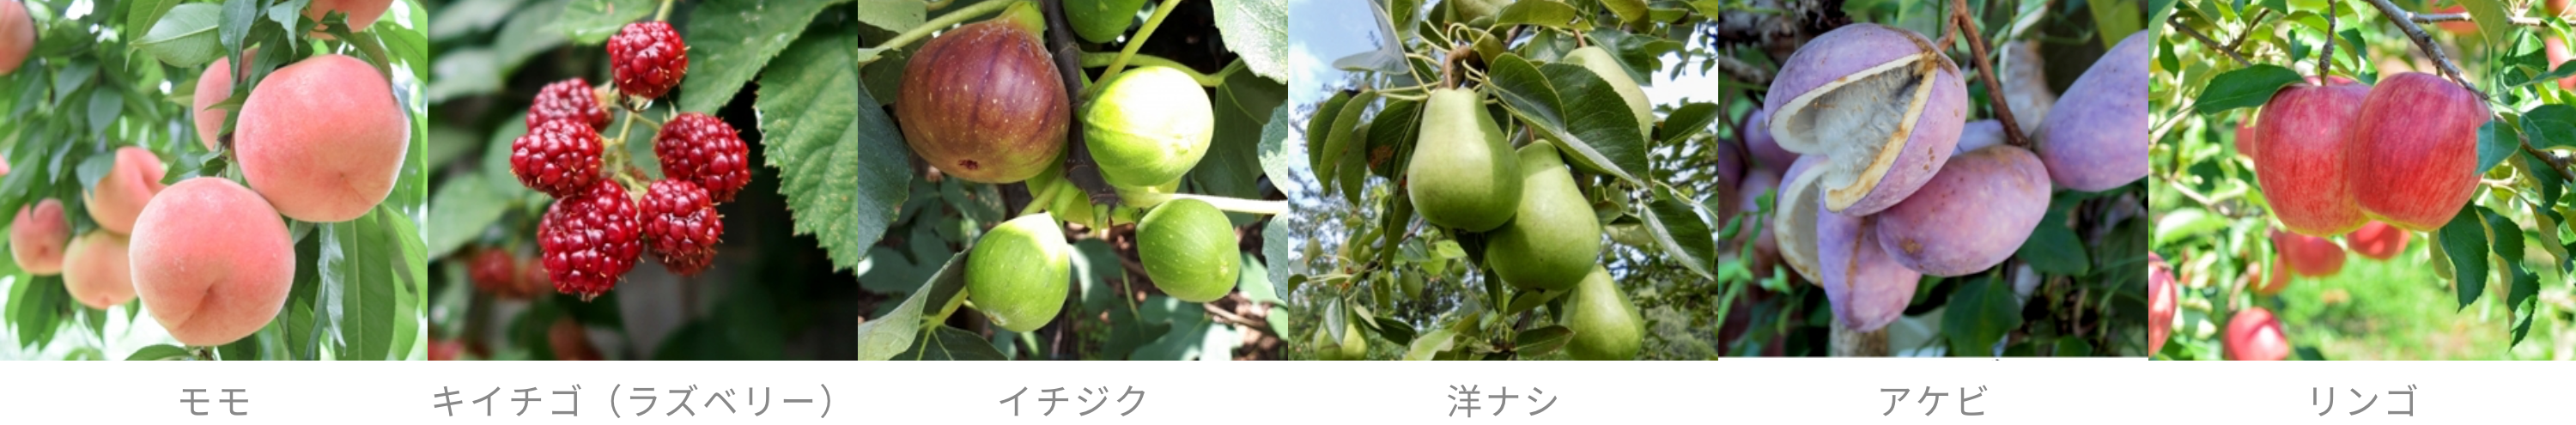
[2360,72,2494,237]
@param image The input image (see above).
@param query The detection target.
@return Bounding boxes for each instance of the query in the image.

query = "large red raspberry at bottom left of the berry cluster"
[536,183,644,301]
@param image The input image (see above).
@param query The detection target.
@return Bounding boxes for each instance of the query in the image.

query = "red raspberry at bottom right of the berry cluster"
[644,180,724,276]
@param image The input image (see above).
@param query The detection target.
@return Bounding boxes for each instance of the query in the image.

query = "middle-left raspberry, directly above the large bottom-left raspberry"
[510,121,600,198]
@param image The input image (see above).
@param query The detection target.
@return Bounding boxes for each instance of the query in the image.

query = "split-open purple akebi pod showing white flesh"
[1762,23,1958,216]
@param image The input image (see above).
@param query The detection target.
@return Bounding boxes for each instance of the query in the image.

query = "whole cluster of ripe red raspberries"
[502,21,752,301]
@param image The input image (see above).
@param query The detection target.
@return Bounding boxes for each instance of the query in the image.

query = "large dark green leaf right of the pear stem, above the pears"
[1486,54,1651,185]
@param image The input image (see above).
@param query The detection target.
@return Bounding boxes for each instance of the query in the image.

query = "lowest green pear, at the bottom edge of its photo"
[1564,265,1646,361]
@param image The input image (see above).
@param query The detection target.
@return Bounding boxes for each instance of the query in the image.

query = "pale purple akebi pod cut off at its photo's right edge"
[2032,31,2154,191]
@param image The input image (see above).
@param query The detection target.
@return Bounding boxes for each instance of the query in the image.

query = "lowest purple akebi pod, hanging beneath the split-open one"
[1816,211,1924,332]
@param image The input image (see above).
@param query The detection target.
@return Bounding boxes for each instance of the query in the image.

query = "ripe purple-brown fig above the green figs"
[894,5,1072,185]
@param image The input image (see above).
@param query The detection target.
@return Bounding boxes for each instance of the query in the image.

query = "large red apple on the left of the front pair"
[2254,82,2370,237]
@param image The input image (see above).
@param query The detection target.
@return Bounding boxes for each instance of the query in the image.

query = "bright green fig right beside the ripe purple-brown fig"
[1082,67,1216,185]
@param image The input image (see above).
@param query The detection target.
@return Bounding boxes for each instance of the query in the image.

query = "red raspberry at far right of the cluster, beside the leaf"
[652,113,752,203]
